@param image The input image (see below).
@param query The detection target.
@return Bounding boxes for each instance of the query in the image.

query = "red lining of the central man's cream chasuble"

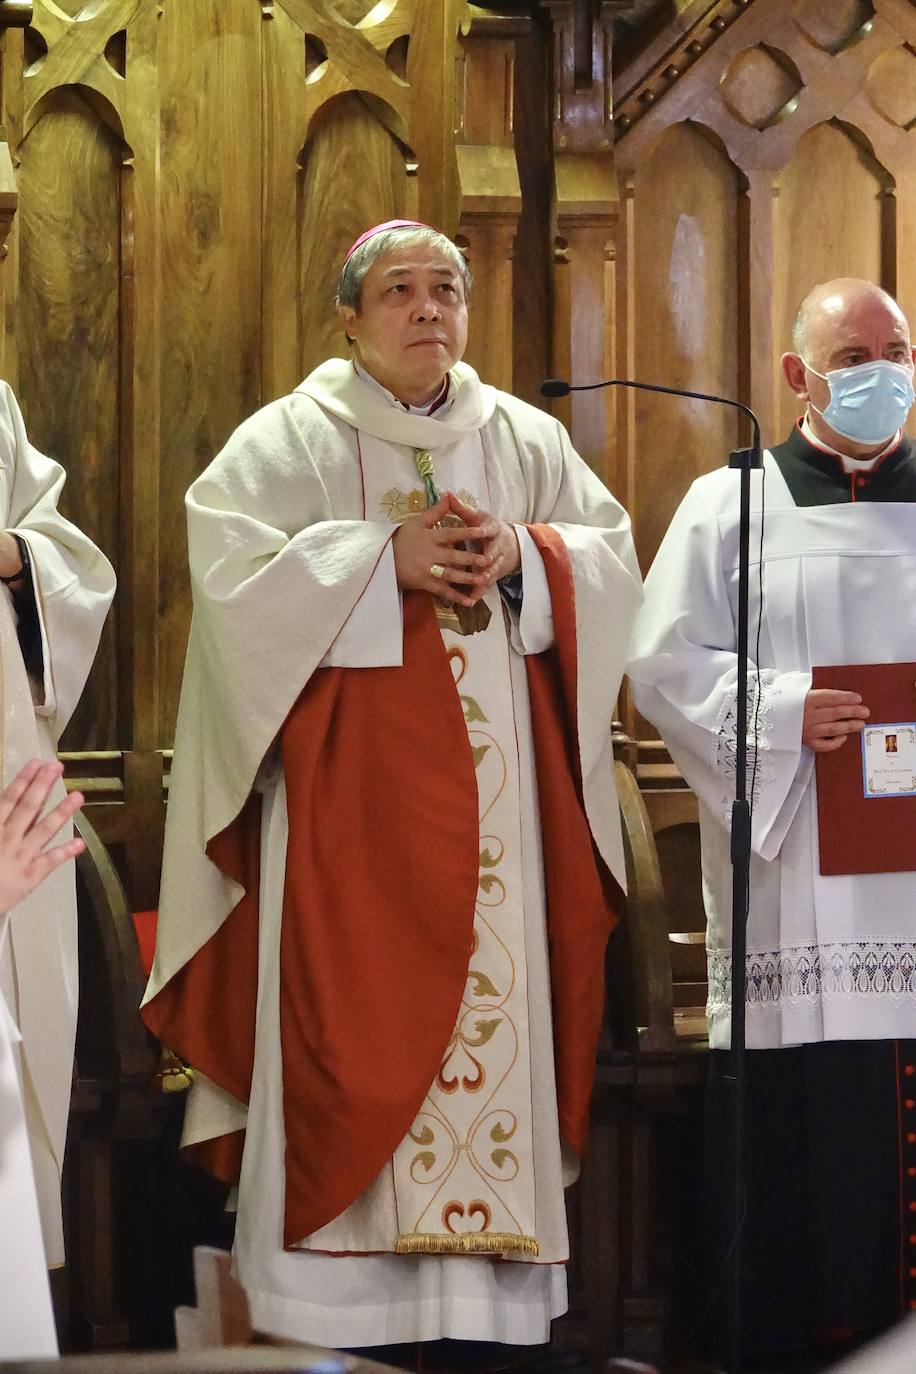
[144,525,621,1246]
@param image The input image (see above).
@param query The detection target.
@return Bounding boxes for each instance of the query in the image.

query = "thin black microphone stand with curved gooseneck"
[541,378,762,1374]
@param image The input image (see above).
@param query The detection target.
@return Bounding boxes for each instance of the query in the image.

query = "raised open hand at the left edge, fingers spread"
[0,758,85,912]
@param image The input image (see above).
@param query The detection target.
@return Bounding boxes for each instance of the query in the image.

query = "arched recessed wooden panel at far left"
[10,87,124,749]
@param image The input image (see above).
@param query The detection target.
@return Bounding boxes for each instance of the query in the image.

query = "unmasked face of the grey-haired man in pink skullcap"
[339,242,467,405]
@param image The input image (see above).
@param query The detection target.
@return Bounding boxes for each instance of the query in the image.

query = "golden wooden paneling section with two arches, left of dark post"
[0,0,480,750]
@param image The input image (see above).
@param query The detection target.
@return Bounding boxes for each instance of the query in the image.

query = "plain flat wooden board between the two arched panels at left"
[158,0,264,743]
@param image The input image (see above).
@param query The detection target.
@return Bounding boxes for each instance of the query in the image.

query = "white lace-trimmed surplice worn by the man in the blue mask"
[628,453,916,1048]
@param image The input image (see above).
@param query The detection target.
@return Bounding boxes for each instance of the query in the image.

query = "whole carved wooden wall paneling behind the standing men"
[0,0,916,907]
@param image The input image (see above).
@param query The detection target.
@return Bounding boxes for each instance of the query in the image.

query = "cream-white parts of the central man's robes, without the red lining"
[146,359,640,1347]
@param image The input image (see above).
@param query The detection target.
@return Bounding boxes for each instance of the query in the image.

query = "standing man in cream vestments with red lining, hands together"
[146,224,640,1345]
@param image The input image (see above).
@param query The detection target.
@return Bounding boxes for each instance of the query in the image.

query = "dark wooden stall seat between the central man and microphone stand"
[555,761,707,1359]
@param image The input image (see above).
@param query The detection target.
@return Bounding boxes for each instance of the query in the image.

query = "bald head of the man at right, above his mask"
[792,276,909,372]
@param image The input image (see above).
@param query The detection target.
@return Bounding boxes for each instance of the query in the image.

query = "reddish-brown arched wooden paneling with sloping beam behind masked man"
[614,0,916,588]
